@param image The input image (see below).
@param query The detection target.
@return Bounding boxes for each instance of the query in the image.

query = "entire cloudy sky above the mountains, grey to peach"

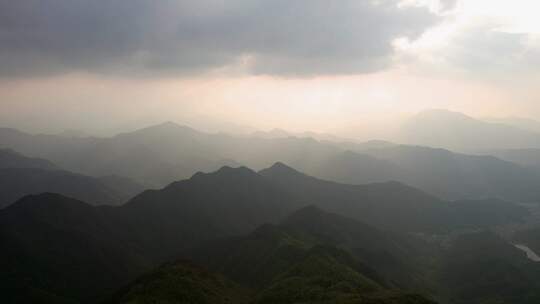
[0,0,540,137]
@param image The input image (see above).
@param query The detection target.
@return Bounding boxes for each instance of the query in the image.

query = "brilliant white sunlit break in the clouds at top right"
[394,0,540,70]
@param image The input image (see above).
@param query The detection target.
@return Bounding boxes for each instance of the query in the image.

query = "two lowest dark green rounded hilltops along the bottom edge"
[114,245,433,304]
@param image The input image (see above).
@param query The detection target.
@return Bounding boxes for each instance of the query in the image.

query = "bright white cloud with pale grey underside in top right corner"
[395,0,540,81]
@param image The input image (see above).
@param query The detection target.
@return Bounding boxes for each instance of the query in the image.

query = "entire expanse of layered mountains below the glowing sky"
[0,108,540,304]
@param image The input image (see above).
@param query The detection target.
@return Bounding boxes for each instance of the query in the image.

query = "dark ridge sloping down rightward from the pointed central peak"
[260,163,527,231]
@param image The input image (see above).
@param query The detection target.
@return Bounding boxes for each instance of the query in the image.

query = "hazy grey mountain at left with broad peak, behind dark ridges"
[0,122,242,187]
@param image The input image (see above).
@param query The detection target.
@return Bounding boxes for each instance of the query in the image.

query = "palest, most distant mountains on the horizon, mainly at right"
[249,109,540,154]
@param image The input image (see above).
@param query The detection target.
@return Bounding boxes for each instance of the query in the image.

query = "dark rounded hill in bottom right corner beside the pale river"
[438,232,540,304]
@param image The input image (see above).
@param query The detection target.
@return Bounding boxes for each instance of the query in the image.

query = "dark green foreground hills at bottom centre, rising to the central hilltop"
[111,207,438,303]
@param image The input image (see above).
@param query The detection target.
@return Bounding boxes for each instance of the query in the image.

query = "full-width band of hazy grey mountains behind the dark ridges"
[0,121,540,202]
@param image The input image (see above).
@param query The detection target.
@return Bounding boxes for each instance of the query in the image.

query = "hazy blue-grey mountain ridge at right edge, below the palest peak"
[358,146,540,202]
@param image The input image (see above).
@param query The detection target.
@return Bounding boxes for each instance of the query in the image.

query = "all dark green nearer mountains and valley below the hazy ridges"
[0,164,540,304]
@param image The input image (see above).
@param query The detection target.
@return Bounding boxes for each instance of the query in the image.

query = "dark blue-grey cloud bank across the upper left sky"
[0,0,436,76]
